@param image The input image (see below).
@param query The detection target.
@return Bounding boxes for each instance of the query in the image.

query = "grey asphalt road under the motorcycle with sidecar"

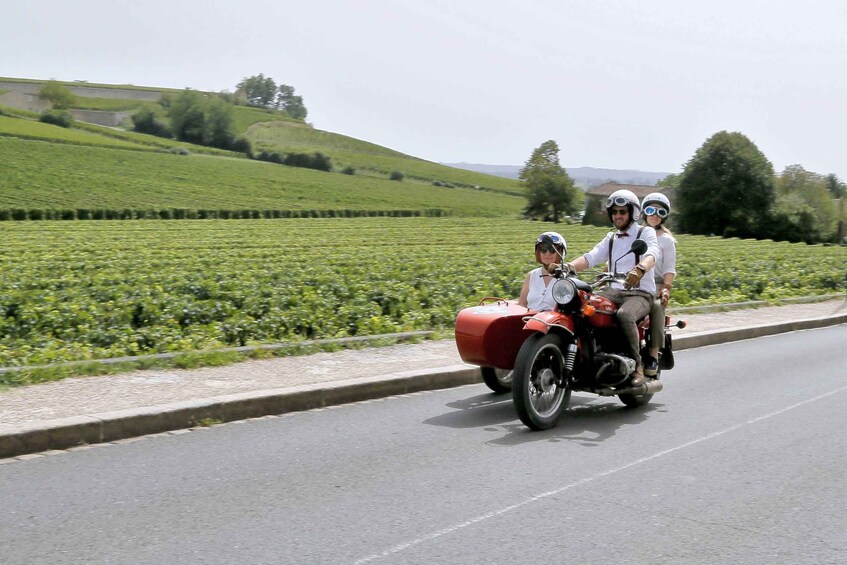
[0,325,847,565]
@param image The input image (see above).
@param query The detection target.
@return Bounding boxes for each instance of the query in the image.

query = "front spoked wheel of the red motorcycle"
[512,334,571,430]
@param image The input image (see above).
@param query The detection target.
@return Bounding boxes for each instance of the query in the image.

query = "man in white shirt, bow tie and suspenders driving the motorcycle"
[565,190,659,385]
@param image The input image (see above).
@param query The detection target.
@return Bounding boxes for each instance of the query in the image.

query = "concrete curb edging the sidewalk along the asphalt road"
[0,314,847,458]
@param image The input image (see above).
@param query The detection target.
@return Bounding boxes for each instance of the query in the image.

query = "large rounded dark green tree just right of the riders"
[677,131,775,237]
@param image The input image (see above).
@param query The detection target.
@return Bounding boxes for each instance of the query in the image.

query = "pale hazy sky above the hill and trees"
[6,0,847,176]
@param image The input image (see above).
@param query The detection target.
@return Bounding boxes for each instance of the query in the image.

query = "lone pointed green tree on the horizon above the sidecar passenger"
[518,139,576,222]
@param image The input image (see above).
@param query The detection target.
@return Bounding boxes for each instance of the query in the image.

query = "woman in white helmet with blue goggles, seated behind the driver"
[641,192,676,377]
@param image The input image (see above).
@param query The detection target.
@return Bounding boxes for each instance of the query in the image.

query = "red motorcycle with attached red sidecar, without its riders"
[455,240,685,430]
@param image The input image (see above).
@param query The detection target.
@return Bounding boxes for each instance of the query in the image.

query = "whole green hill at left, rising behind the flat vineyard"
[0,77,524,219]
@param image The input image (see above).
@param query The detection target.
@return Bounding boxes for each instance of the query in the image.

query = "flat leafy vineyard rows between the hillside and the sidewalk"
[0,218,847,372]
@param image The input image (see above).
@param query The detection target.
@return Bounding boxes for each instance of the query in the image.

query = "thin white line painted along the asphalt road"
[353,386,847,565]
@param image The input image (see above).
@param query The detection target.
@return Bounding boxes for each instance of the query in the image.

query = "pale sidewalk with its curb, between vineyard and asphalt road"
[0,299,847,461]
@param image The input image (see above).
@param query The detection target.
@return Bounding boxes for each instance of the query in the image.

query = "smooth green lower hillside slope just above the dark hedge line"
[0,137,523,216]
